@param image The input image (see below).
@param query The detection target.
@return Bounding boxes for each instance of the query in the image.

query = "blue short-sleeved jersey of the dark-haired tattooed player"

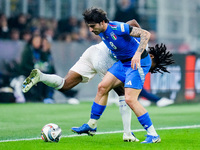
[99,21,140,60]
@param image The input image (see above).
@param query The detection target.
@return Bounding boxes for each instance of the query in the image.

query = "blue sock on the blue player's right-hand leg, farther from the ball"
[138,112,152,130]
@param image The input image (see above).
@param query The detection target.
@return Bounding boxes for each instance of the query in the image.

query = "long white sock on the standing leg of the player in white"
[119,96,132,133]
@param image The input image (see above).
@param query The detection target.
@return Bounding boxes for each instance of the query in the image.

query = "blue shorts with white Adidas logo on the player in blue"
[108,55,151,89]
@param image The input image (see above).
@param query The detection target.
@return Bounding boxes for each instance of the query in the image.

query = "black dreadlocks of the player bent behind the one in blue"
[149,43,175,74]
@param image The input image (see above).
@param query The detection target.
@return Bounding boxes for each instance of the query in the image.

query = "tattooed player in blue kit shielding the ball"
[72,7,166,143]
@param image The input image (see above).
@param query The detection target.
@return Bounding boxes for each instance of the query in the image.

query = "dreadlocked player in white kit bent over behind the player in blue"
[22,19,173,142]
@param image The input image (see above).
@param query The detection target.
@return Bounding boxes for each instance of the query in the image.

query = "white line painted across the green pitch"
[0,125,200,143]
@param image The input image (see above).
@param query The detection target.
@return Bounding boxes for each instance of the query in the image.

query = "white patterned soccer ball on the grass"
[41,123,62,142]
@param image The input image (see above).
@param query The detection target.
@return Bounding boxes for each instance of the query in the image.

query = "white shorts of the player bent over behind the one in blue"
[70,42,116,83]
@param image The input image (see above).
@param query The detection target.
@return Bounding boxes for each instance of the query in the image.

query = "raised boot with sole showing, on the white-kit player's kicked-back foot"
[22,69,41,93]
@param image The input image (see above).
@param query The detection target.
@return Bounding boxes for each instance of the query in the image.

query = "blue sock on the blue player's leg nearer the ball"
[90,102,106,119]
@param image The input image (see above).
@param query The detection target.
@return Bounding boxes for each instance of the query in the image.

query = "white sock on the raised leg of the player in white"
[40,73,65,90]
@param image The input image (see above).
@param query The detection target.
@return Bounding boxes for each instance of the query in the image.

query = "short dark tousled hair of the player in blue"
[82,7,109,24]
